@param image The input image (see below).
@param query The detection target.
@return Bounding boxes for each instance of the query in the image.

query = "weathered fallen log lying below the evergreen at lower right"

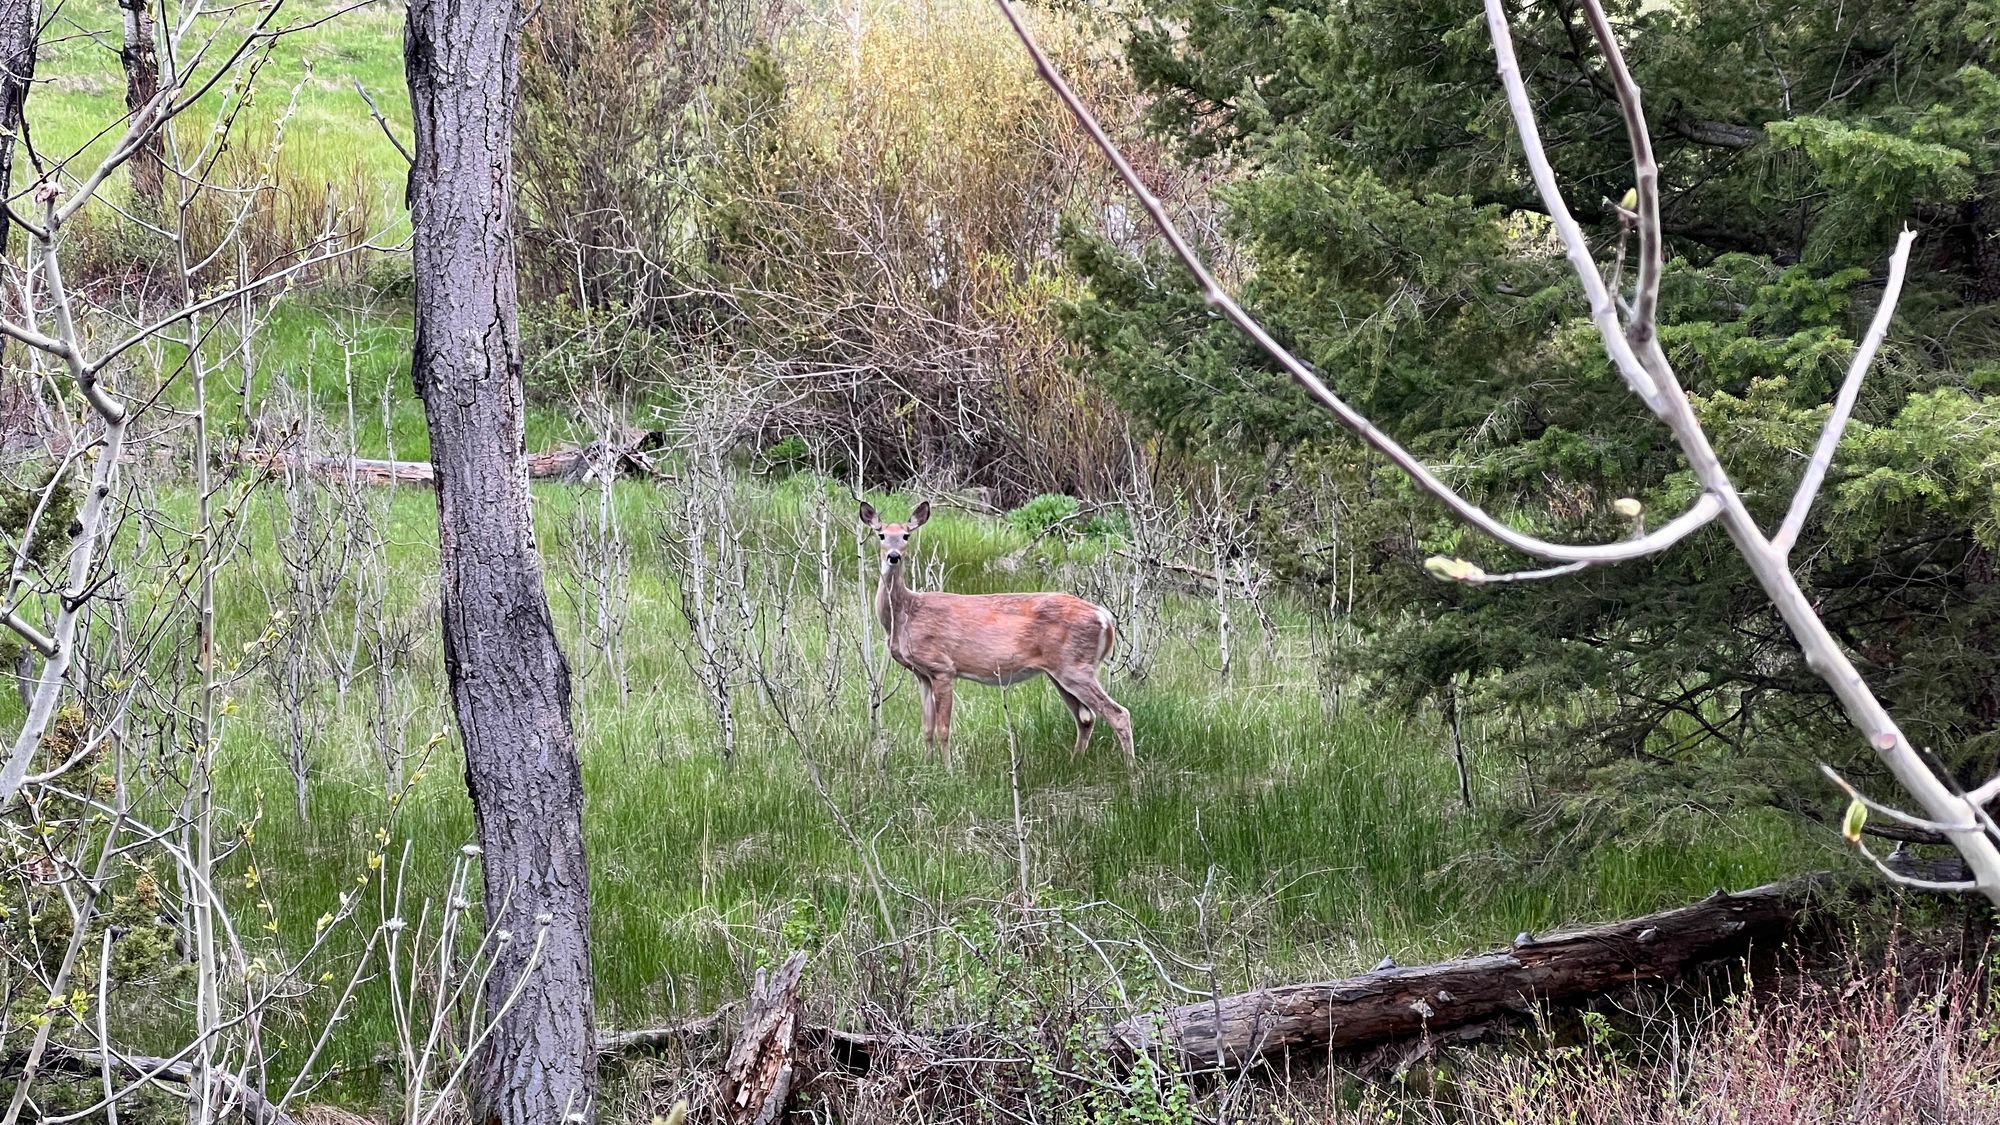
[1112,875,1834,1067]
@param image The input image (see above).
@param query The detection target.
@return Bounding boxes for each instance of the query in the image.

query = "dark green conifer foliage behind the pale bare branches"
[1064,0,2000,841]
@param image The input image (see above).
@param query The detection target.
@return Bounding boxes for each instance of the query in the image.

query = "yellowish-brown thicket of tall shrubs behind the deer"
[518,0,1194,502]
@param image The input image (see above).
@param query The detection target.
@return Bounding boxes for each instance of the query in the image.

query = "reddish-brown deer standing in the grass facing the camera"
[860,500,1138,765]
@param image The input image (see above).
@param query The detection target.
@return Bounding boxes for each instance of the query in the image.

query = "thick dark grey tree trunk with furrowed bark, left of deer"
[404,0,596,1125]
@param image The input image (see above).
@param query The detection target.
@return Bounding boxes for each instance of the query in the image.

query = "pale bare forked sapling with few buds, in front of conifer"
[996,0,2000,905]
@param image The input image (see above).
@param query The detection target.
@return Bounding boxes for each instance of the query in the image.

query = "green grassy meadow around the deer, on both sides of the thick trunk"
[0,294,1838,1065]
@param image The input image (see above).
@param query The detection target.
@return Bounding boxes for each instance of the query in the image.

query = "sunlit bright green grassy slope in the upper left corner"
[30,0,408,288]
